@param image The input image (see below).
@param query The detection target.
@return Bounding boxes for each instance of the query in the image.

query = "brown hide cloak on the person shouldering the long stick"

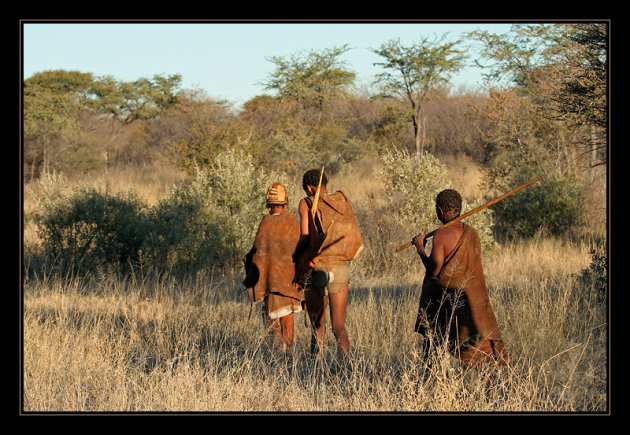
[415,224,507,365]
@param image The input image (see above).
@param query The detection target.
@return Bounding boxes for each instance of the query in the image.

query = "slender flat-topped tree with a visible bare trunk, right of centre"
[372,35,465,153]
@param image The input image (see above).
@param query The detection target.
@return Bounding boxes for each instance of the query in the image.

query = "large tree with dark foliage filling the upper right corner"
[468,22,608,167]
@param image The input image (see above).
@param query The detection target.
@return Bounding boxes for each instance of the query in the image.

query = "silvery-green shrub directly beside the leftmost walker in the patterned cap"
[145,150,287,270]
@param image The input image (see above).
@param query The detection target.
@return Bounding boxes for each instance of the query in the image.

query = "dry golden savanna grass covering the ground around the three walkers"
[22,161,610,414]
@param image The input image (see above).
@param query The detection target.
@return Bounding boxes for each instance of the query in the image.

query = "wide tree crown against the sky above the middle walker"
[262,45,356,110]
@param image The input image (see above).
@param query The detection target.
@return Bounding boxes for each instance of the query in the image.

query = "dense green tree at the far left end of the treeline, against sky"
[23,70,181,175]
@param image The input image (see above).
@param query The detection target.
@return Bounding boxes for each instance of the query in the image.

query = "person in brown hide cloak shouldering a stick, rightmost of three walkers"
[412,189,508,367]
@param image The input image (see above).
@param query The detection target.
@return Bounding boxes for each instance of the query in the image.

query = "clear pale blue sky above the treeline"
[22,21,511,106]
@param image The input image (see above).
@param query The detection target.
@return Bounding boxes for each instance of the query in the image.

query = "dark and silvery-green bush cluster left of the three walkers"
[29,150,286,273]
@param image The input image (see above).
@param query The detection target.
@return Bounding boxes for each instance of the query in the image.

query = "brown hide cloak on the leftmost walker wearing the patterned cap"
[243,211,304,319]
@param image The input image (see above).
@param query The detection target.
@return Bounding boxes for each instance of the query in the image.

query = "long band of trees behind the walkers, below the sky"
[23,23,608,181]
